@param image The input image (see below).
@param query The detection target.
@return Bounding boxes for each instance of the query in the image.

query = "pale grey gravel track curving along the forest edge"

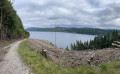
[0,41,30,74]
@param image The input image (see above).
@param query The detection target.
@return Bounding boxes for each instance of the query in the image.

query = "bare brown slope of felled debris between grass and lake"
[28,39,120,67]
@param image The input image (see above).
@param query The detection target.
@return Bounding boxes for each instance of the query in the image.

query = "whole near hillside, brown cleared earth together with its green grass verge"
[19,39,120,74]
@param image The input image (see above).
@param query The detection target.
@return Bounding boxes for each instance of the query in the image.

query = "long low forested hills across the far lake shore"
[26,27,120,35]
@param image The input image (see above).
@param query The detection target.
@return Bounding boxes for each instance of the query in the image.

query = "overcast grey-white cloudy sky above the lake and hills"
[13,0,120,29]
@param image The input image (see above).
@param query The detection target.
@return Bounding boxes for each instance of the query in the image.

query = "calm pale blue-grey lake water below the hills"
[30,31,95,49]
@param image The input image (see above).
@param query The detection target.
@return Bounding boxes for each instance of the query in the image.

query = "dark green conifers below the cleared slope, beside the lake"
[71,30,120,50]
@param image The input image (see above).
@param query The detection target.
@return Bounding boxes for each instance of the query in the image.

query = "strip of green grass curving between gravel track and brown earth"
[19,40,120,74]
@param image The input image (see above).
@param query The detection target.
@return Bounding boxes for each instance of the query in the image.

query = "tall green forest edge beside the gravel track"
[0,0,29,39]
